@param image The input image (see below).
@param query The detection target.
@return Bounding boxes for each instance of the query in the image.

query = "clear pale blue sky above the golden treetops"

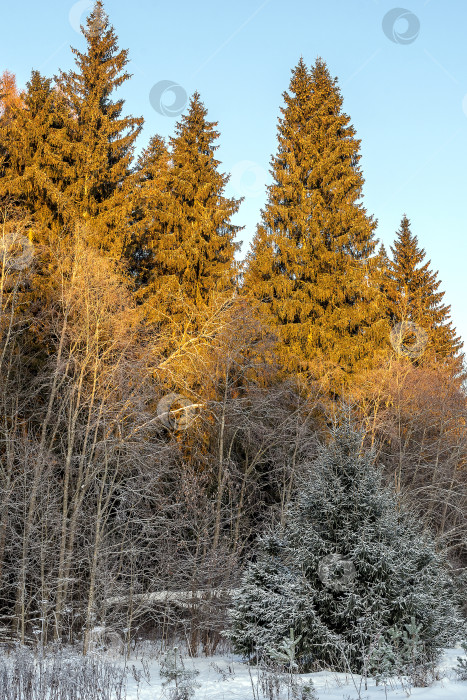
[0,0,467,348]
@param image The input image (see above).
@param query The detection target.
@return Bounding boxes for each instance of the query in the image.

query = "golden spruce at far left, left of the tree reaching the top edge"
[0,70,73,326]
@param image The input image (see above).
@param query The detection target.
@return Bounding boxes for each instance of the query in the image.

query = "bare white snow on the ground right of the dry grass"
[121,648,467,700]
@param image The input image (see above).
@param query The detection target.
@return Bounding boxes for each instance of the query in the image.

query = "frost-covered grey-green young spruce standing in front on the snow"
[227,418,462,673]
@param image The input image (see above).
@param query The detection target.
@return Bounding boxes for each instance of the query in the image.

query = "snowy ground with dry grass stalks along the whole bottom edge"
[0,642,467,700]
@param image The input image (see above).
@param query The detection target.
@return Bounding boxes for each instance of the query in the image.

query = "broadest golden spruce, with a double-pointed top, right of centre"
[245,58,388,392]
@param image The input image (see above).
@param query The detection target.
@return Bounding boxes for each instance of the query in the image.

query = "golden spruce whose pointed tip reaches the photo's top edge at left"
[57,0,143,257]
